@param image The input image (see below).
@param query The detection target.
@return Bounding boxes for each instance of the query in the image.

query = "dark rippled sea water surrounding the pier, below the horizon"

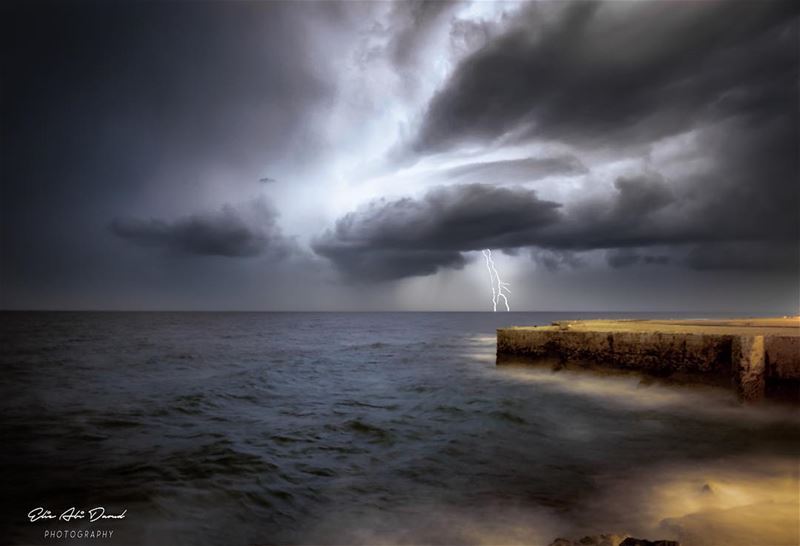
[0,313,800,545]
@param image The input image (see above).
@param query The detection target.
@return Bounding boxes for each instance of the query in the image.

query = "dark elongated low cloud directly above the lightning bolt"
[313,184,559,280]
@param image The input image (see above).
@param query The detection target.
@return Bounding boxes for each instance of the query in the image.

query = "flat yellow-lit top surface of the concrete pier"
[501,316,800,337]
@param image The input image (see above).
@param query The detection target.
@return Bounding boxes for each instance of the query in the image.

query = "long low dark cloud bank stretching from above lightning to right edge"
[313,160,797,280]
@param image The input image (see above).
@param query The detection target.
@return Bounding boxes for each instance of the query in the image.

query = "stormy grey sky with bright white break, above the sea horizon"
[0,1,800,314]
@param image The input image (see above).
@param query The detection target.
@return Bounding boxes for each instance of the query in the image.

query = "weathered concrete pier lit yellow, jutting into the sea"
[497,317,800,401]
